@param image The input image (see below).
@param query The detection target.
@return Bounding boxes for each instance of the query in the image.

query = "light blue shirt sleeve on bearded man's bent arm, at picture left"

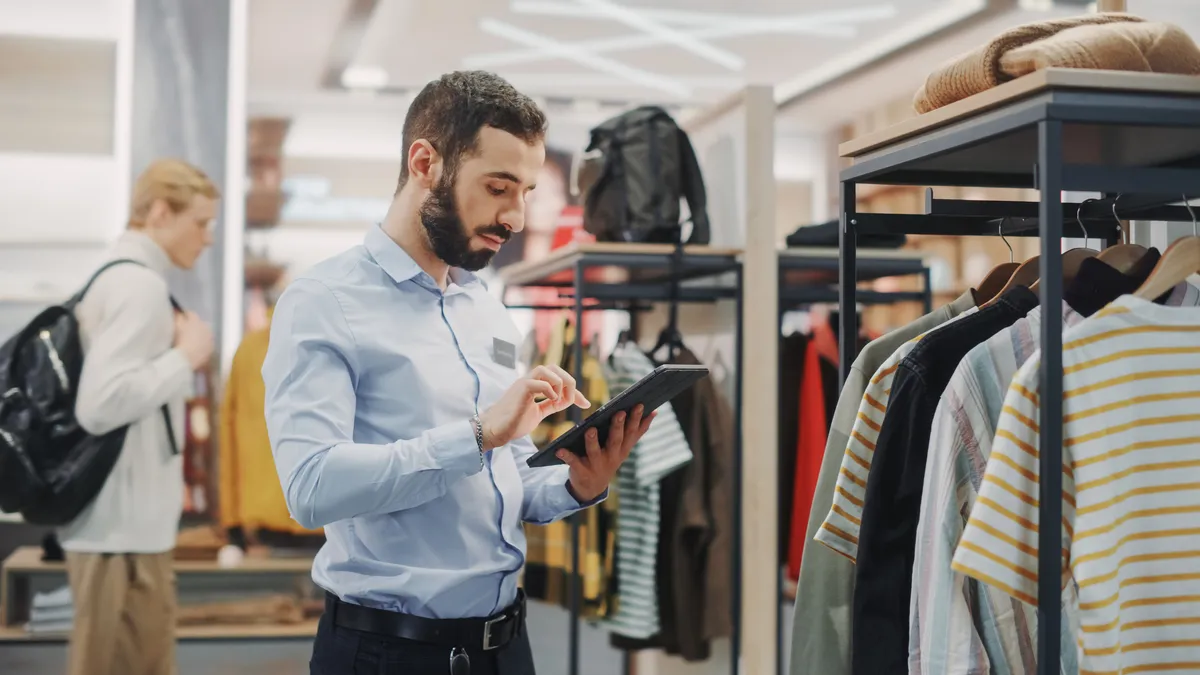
[263,279,482,527]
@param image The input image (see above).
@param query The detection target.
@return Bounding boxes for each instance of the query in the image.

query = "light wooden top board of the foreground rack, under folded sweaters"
[838,68,1200,157]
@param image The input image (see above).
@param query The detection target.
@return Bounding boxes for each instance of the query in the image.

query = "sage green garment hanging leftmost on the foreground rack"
[788,291,974,675]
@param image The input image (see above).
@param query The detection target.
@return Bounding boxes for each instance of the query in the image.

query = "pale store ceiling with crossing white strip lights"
[248,0,1200,126]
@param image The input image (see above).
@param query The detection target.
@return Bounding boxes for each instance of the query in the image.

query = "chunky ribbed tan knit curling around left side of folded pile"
[913,12,1142,113]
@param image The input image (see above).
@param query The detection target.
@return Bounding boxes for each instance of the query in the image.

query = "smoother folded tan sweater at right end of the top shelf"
[1000,23,1200,78]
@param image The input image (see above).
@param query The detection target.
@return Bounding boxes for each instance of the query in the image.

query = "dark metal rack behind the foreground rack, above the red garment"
[775,247,934,673]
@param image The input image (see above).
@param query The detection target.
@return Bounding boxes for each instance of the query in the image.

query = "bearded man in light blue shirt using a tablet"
[263,72,654,675]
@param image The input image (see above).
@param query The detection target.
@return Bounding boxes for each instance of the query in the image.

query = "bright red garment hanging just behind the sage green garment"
[787,340,829,581]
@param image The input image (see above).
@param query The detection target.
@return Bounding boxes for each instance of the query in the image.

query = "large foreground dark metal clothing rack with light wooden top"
[839,68,1200,675]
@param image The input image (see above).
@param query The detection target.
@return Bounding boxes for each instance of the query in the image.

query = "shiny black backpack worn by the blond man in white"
[0,259,180,526]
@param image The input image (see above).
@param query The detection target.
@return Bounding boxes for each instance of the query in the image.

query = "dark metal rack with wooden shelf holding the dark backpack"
[500,243,742,675]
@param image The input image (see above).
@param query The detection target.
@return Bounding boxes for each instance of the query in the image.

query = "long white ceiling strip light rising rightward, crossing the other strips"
[463,2,896,68]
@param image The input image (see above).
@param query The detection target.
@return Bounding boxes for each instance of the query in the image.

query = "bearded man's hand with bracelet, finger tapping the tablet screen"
[479,365,592,452]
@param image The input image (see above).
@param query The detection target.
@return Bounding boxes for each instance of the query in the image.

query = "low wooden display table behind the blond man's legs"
[0,546,322,643]
